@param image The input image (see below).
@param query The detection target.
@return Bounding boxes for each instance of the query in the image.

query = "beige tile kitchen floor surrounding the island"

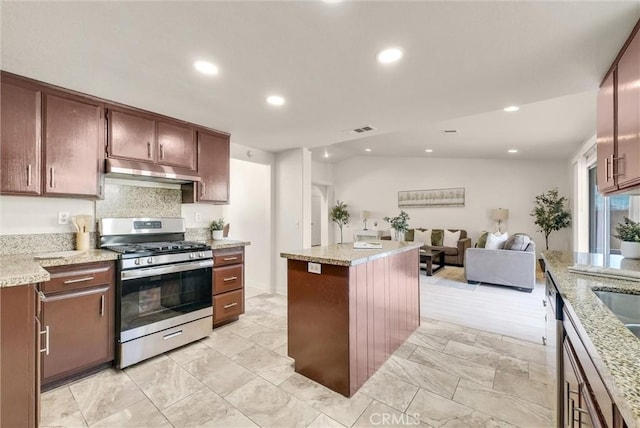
[41,282,553,428]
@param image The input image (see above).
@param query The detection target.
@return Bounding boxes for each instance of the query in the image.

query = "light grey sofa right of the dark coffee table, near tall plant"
[464,234,536,293]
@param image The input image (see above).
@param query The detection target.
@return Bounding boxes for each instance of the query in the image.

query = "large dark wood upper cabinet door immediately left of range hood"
[44,94,104,196]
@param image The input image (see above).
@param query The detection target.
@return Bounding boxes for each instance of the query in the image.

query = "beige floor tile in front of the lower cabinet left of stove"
[69,369,146,425]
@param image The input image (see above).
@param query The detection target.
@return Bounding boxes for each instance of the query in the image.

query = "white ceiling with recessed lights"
[0,0,640,161]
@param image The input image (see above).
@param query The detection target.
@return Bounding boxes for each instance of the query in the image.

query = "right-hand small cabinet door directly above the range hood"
[158,121,196,170]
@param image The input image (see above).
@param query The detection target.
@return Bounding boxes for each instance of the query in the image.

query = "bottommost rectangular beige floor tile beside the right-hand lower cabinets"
[453,379,552,428]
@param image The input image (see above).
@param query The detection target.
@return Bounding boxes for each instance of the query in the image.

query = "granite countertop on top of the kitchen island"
[280,241,424,266]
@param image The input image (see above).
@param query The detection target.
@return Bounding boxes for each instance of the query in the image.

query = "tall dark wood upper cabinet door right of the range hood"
[196,132,229,204]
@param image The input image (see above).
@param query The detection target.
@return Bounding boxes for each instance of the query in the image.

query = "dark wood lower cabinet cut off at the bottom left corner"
[0,284,40,428]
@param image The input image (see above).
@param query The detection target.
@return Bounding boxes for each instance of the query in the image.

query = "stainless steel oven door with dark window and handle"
[118,259,213,343]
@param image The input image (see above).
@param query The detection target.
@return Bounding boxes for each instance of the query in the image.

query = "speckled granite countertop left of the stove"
[0,250,118,288]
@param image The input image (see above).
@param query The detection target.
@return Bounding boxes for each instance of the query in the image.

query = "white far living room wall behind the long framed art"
[333,156,572,250]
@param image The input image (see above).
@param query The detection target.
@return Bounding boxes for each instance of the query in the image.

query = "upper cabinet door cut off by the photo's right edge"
[617,33,640,189]
